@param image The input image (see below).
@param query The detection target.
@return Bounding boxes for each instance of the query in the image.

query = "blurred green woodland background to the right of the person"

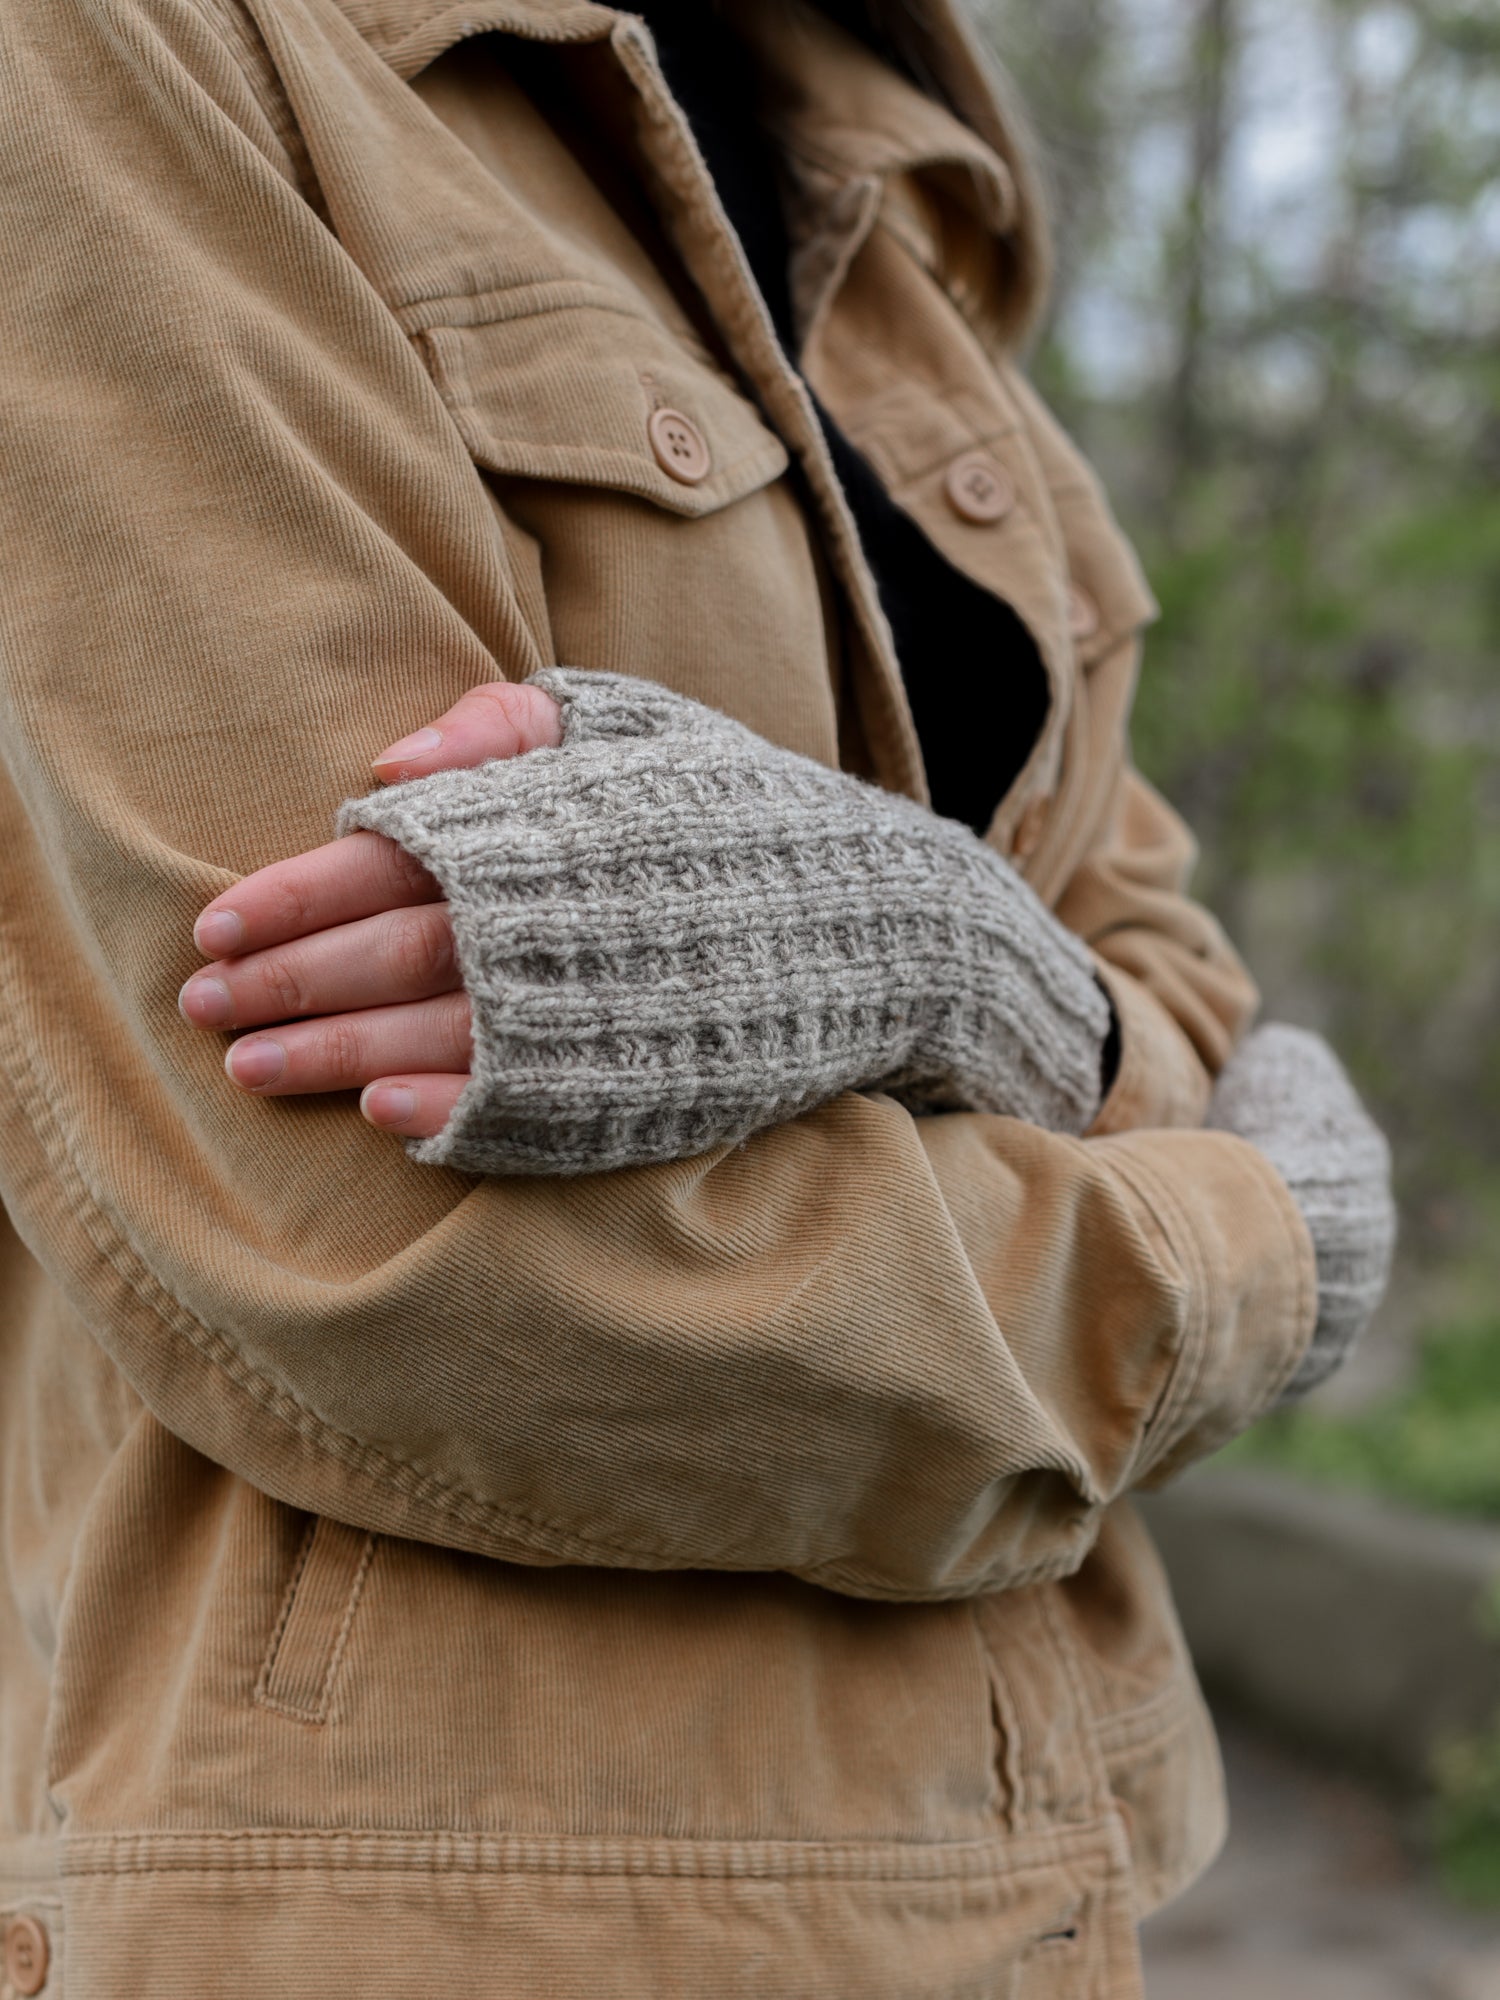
[972,0,1500,1996]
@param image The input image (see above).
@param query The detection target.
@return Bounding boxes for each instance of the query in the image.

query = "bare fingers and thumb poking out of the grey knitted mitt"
[178,682,562,1138]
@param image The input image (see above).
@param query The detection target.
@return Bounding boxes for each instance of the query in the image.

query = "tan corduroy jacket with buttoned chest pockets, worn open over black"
[0,0,1312,2000]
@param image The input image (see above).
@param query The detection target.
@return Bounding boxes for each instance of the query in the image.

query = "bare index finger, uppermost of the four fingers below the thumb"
[192,834,442,958]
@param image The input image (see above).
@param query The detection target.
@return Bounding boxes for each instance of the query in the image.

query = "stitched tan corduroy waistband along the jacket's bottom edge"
[0,1814,1140,2000]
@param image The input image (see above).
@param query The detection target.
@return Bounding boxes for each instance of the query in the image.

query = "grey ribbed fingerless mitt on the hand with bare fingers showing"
[338,668,1110,1174]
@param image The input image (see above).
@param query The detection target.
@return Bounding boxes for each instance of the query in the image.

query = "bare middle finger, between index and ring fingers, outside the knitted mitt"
[178,902,462,1028]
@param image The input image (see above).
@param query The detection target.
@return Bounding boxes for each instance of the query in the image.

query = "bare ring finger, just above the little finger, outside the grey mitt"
[224,992,470,1098]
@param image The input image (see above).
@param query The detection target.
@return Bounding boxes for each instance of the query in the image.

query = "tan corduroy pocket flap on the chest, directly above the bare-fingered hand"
[416,294,788,516]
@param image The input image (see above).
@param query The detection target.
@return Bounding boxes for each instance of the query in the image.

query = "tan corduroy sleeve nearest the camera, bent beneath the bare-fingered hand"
[0,0,1312,1598]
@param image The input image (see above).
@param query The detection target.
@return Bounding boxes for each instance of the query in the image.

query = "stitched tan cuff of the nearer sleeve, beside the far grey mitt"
[1100,1132,1318,1486]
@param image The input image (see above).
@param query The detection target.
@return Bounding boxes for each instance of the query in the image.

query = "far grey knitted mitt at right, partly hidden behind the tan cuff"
[1208,1026,1396,1402]
